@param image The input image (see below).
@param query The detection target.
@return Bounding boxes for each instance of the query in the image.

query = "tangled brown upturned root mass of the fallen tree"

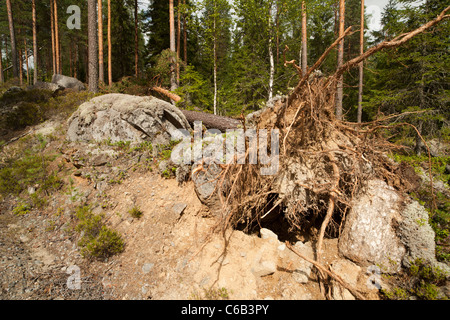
[197,7,450,299]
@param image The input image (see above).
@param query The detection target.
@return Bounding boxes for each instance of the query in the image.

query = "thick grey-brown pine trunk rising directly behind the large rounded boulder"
[88,0,98,93]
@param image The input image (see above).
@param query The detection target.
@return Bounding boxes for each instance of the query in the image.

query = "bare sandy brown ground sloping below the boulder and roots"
[0,114,384,300]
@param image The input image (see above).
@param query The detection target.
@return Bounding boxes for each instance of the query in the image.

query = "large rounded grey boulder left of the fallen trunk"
[67,94,191,145]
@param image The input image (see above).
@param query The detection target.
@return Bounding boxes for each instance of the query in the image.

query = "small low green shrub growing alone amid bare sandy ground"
[75,206,125,259]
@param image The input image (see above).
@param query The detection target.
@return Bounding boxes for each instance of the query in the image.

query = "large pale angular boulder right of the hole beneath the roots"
[338,180,447,273]
